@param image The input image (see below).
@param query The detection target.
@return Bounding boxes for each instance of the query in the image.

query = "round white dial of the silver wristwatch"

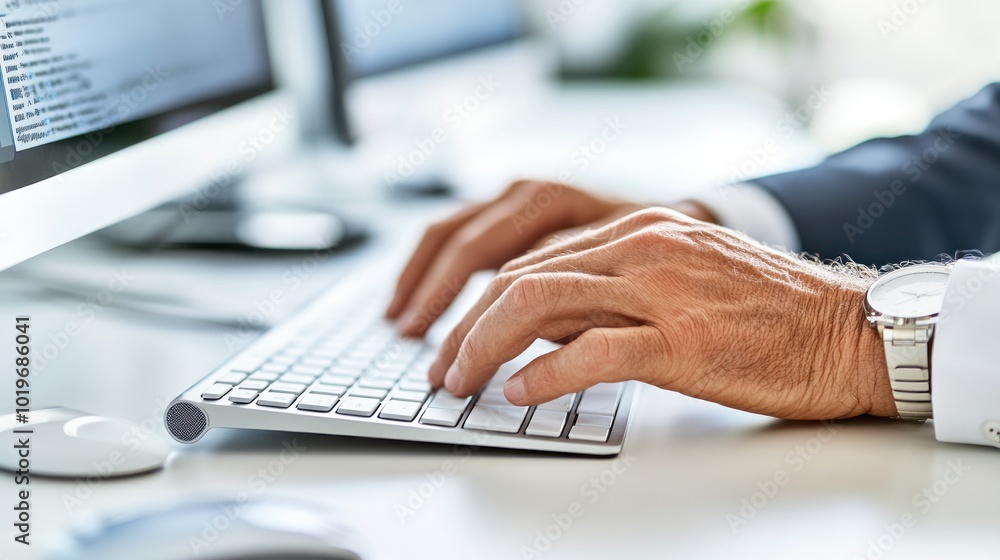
[868,266,949,319]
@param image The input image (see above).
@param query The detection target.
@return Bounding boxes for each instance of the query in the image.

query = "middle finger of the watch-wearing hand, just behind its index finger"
[427,249,615,387]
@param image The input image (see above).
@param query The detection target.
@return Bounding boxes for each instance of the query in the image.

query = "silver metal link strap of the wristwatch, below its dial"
[879,325,934,420]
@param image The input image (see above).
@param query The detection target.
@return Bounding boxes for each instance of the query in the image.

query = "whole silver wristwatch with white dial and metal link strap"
[865,264,951,421]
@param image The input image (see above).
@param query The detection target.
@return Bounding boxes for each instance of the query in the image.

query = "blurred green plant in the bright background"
[609,0,794,79]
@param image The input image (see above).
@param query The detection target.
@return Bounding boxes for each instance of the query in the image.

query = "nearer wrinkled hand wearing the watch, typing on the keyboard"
[429,209,895,419]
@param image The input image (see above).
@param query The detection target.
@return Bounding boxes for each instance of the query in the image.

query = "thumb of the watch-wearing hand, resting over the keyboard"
[504,326,662,406]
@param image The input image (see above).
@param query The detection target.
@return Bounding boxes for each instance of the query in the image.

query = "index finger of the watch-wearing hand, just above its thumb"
[444,274,637,396]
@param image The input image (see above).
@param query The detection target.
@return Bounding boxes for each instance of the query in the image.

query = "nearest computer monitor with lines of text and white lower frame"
[0,0,282,270]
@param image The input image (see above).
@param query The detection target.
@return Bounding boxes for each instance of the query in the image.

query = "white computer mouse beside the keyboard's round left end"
[0,408,170,478]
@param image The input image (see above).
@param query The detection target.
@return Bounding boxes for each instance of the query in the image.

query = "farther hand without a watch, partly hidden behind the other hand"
[386,181,711,336]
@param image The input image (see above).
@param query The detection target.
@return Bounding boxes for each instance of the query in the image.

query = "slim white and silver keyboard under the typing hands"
[164,266,636,456]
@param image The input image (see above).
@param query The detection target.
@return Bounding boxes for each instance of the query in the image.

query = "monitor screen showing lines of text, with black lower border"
[0,0,272,194]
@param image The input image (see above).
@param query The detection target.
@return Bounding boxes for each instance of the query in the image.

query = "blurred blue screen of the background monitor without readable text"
[336,0,522,78]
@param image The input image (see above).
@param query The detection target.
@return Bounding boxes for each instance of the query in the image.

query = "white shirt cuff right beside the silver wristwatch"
[931,260,1000,446]
